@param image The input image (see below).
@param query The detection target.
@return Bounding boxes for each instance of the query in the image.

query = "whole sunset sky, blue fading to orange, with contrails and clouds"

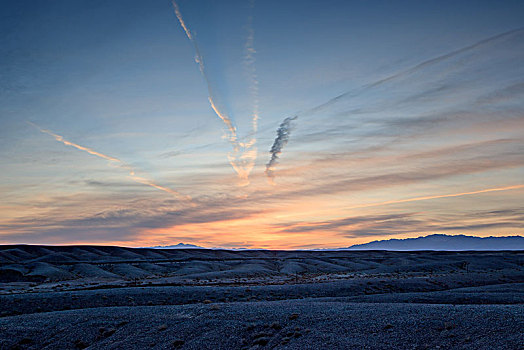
[0,0,524,249]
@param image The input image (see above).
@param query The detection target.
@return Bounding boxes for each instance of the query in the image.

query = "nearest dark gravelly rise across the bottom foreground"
[0,300,524,349]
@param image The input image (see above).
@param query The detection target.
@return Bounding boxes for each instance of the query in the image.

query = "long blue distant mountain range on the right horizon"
[343,234,524,251]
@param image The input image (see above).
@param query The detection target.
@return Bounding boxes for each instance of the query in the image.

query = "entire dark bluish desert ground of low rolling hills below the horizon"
[0,245,524,349]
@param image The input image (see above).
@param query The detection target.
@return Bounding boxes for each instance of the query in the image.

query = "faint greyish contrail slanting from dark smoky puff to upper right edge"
[308,28,524,114]
